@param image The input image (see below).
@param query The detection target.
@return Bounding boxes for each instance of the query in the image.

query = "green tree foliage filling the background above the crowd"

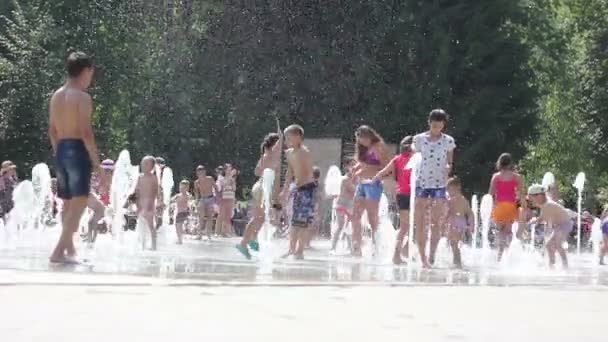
[0,0,608,206]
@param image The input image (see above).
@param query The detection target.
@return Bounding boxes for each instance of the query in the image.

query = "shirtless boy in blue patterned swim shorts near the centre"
[281,125,316,259]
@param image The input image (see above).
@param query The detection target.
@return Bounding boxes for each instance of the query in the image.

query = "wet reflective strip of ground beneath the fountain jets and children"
[0,239,608,286]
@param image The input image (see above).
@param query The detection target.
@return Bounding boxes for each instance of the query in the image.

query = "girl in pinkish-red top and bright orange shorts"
[490,153,526,262]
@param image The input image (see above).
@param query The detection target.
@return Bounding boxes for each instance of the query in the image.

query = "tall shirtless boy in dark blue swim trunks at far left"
[49,52,99,263]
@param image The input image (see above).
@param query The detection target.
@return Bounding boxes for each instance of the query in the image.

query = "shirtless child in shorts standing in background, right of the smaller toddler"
[194,165,220,241]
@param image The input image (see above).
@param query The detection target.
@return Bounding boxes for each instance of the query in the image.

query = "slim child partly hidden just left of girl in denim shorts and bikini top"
[330,160,356,254]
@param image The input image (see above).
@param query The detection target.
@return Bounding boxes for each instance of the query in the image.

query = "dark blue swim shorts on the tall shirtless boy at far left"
[55,139,93,200]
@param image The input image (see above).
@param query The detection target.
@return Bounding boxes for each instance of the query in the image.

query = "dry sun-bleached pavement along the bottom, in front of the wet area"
[0,286,608,342]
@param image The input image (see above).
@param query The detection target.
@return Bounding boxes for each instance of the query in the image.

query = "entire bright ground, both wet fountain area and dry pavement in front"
[0,239,608,342]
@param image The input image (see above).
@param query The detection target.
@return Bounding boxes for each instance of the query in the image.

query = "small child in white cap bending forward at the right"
[528,184,572,268]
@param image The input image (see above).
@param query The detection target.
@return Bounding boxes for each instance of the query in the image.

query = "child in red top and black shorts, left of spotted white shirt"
[374,136,412,265]
